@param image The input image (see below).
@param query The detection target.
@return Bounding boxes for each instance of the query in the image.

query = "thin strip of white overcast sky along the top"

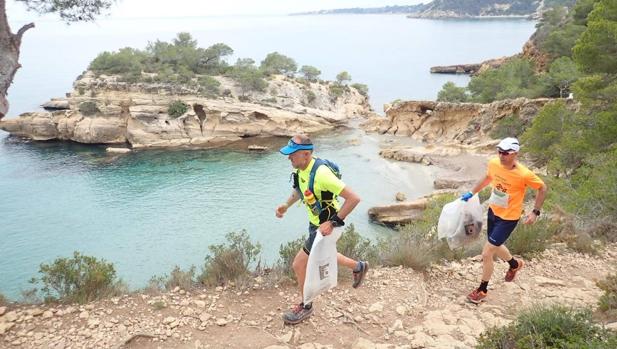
[7,0,430,21]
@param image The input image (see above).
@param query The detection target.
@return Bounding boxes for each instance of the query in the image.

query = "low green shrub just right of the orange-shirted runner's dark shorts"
[506,216,558,257]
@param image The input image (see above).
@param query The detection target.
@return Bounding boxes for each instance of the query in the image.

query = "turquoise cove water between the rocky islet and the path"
[0,131,432,297]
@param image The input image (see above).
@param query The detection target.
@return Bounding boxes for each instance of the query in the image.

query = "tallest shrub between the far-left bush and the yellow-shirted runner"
[199,230,261,286]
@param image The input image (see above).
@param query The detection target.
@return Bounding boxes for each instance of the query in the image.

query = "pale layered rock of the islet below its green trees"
[0,72,370,148]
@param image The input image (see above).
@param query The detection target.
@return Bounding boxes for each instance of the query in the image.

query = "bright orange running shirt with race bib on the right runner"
[486,158,544,220]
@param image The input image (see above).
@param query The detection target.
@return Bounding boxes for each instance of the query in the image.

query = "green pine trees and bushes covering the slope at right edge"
[440,0,617,237]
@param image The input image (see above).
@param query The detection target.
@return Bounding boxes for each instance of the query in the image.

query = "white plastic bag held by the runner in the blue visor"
[303,229,342,304]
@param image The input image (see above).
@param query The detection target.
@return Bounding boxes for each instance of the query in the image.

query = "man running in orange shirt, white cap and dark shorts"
[461,137,548,304]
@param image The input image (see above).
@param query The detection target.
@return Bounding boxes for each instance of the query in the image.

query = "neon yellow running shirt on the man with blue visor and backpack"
[298,158,345,225]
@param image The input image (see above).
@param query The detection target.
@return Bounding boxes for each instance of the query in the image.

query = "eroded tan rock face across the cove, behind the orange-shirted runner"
[362,98,568,145]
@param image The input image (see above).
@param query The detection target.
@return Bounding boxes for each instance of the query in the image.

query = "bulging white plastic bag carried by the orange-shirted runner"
[437,195,482,249]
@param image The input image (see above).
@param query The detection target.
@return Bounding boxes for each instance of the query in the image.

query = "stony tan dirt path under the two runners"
[0,244,617,349]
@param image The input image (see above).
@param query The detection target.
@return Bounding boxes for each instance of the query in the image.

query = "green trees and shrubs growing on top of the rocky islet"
[88,33,368,102]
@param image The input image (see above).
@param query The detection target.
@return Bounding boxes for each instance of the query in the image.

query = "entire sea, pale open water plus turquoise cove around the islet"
[0,15,534,298]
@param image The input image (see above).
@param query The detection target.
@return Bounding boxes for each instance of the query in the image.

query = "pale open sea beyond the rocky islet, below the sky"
[9,15,535,115]
